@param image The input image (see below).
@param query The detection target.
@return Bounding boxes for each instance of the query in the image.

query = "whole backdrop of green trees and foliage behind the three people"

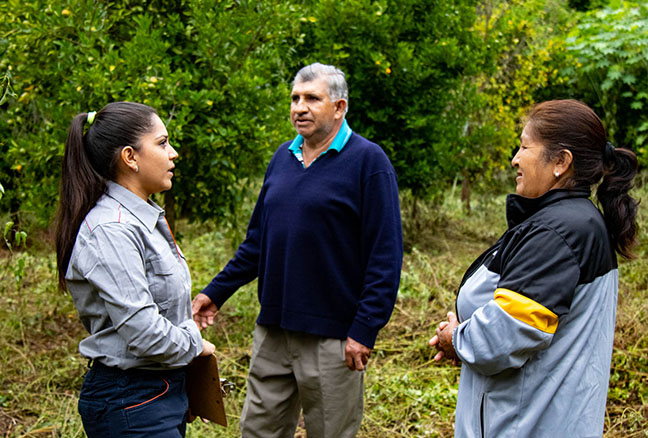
[0,0,648,229]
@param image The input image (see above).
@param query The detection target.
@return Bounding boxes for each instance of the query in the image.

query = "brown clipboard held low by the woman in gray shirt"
[187,354,227,427]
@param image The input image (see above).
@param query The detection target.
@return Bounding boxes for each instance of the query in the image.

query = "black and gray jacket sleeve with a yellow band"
[452,227,580,375]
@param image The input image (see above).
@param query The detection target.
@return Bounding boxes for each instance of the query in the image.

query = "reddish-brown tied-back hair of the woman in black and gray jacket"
[527,99,639,258]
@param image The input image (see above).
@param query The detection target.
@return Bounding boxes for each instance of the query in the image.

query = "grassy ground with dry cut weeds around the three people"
[0,186,648,438]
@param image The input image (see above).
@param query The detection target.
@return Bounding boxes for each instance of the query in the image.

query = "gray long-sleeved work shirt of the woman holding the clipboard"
[65,181,202,369]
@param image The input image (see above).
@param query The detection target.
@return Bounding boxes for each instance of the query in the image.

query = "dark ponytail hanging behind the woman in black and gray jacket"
[596,144,639,258]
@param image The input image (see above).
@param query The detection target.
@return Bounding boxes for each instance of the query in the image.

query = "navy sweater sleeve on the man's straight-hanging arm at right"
[348,169,403,348]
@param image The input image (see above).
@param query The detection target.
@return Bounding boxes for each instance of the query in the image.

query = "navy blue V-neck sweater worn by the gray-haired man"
[202,134,403,348]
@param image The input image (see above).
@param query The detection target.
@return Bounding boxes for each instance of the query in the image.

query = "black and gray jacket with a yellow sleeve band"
[453,189,618,438]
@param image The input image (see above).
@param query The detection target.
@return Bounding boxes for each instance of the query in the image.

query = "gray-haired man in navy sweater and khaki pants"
[193,63,403,438]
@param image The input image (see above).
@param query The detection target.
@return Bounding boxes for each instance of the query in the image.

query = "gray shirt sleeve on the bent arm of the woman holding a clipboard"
[80,224,202,366]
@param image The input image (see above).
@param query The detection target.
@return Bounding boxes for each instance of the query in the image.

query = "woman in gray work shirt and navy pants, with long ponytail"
[56,102,214,438]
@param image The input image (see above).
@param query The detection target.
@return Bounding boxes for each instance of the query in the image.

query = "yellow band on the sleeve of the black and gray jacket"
[495,288,558,334]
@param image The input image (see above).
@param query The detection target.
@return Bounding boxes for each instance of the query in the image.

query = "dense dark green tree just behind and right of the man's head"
[297,0,482,196]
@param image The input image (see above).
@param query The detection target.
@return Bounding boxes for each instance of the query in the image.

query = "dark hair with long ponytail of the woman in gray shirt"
[56,102,156,290]
